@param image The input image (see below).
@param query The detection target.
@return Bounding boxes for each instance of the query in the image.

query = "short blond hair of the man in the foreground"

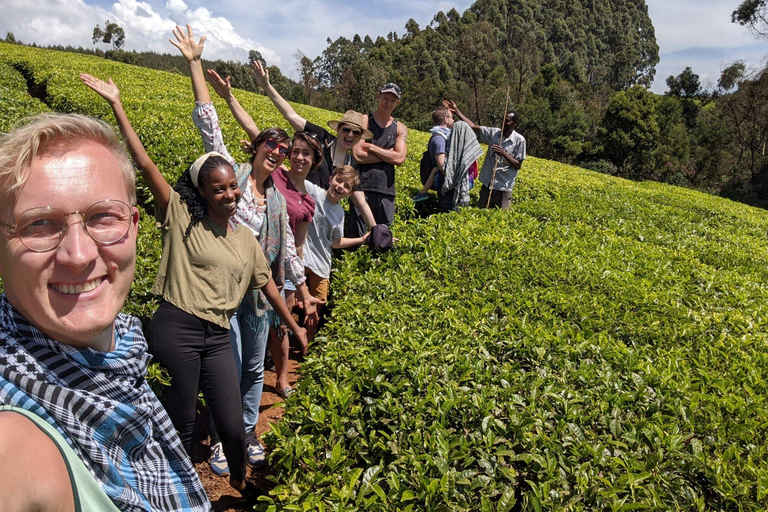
[0,112,136,205]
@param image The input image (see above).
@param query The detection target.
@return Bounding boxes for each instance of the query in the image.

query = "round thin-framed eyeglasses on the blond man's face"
[0,199,138,252]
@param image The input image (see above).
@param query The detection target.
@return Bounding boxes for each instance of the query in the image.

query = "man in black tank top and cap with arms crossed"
[349,83,408,237]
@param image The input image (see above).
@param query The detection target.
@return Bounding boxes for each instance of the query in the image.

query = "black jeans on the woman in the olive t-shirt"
[149,301,246,480]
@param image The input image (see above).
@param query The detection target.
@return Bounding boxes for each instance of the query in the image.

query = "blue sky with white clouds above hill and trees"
[0,0,768,93]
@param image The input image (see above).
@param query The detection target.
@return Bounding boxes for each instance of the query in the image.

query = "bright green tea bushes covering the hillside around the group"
[0,44,768,511]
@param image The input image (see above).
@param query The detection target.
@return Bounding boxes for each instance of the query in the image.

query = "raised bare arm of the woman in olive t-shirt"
[80,73,171,212]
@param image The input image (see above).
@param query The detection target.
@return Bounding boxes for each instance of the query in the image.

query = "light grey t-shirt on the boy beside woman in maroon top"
[304,181,344,278]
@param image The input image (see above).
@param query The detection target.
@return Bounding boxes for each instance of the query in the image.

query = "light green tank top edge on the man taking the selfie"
[0,405,119,512]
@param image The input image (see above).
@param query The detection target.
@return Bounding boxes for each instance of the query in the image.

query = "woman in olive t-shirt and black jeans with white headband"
[80,73,305,500]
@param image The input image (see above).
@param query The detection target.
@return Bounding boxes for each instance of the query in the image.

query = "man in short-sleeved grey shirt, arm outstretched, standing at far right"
[443,100,525,209]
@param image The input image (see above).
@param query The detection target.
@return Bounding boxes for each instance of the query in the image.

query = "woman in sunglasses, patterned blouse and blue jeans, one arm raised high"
[171,25,320,474]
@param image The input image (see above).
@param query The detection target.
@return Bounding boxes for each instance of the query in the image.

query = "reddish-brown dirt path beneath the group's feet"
[195,347,300,512]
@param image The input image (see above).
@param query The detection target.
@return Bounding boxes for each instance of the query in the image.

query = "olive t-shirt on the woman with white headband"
[152,189,272,329]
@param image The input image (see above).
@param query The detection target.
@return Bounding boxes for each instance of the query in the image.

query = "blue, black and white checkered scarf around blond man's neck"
[0,294,211,511]
